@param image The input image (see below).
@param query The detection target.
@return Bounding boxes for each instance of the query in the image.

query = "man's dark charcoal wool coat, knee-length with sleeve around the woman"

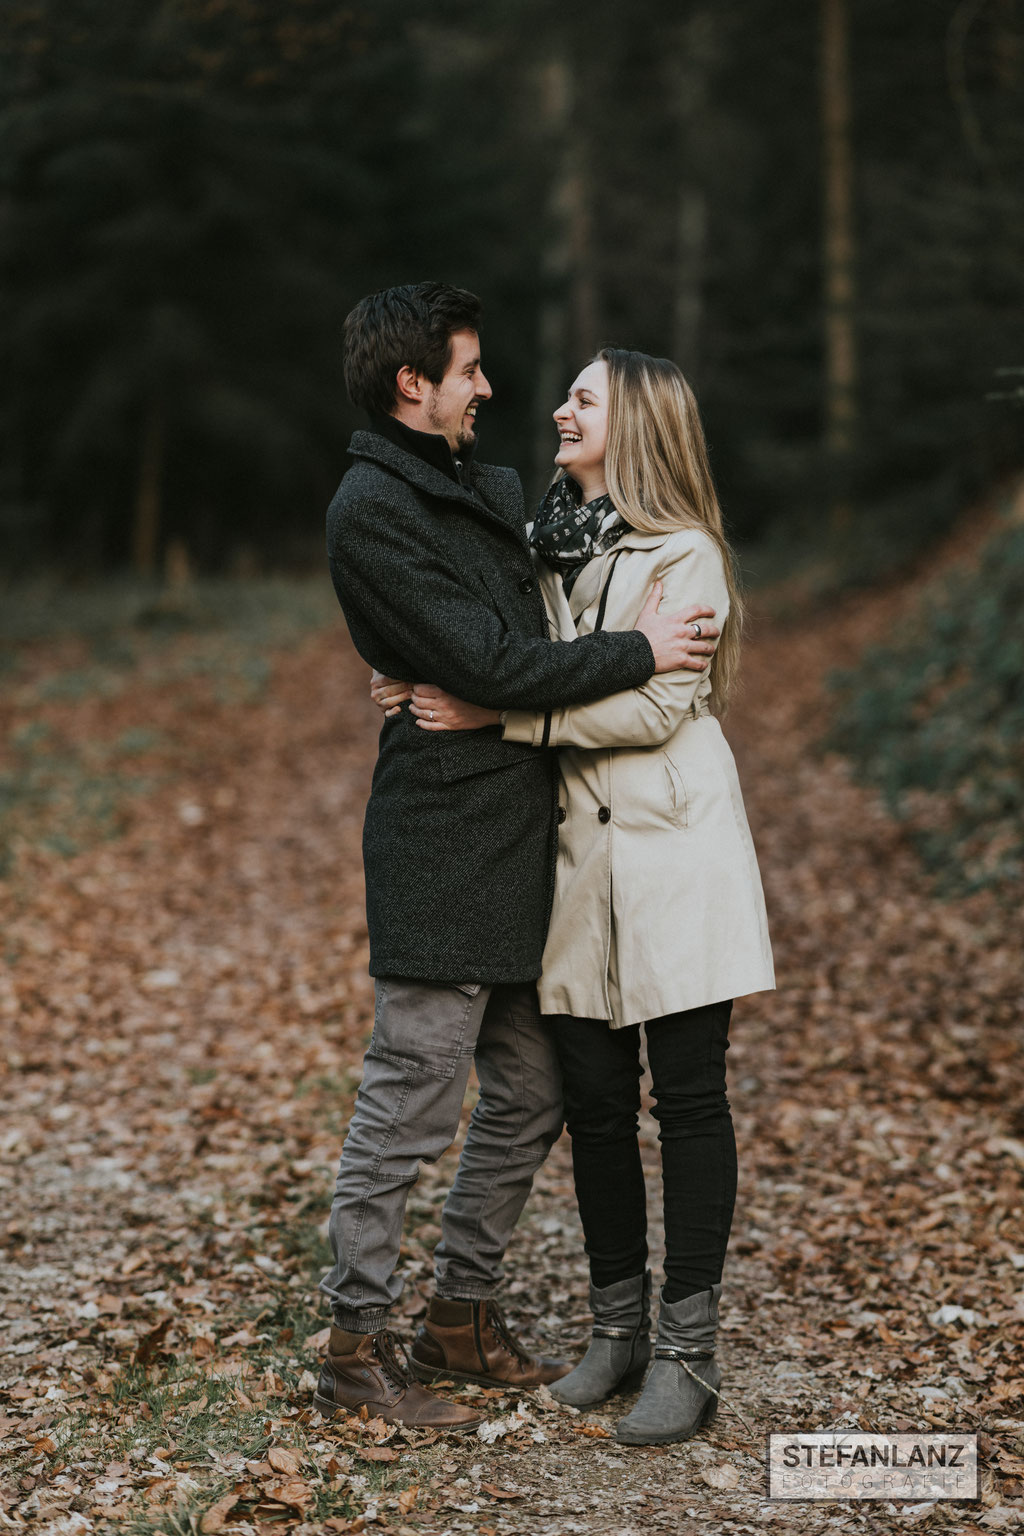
[327,432,654,983]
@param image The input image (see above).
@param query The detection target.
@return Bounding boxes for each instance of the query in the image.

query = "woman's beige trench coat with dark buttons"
[504,528,775,1028]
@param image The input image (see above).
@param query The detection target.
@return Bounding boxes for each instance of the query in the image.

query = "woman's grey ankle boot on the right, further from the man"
[614,1286,722,1445]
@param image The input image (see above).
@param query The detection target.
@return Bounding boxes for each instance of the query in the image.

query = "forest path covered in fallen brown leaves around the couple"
[0,580,1024,1536]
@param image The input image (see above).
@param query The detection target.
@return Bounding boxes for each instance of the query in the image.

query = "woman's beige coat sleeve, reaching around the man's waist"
[504,536,729,746]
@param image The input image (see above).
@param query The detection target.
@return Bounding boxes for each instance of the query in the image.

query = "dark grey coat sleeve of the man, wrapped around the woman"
[329,482,654,710]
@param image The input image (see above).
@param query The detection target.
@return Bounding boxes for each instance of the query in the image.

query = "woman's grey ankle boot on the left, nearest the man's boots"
[550,1270,651,1409]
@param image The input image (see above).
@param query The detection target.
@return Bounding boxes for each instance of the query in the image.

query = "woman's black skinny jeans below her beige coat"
[553,1003,735,1303]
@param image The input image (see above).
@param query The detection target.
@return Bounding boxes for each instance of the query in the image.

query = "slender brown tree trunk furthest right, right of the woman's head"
[821,0,857,530]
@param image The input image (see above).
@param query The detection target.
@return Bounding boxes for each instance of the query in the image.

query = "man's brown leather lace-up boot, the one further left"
[313,1327,484,1430]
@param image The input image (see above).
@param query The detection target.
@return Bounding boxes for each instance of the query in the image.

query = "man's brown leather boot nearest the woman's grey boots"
[411,1296,573,1390]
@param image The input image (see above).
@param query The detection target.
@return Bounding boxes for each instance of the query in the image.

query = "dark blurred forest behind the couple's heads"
[0,0,1024,578]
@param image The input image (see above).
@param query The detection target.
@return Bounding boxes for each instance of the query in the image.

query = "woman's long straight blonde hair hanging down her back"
[593,347,743,714]
